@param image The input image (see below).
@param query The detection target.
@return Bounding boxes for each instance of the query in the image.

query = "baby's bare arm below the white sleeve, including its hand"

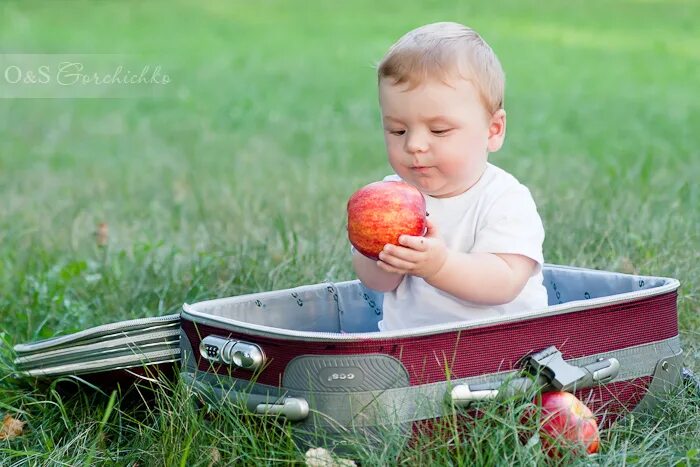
[378,221,537,305]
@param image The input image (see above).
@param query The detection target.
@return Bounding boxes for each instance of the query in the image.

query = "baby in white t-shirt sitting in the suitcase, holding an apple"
[353,23,547,331]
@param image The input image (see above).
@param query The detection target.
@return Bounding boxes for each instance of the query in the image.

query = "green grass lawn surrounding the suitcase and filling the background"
[0,1,700,465]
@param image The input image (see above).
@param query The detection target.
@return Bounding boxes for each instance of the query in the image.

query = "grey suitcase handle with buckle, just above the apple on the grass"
[449,346,620,405]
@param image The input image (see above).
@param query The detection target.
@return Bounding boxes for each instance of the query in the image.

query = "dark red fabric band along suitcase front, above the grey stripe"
[182,291,678,386]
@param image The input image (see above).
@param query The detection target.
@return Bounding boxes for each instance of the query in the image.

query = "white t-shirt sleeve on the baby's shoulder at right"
[471,185,544,267]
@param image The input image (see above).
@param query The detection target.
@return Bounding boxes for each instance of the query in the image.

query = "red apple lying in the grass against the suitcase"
[526,391,600,458]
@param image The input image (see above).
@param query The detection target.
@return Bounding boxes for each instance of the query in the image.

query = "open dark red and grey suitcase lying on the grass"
[15,265,682,440]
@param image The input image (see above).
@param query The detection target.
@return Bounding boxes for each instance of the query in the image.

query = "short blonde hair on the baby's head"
[377,22,505,113]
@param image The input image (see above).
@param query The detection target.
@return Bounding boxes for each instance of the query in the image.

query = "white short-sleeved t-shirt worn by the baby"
[379,164,547,331]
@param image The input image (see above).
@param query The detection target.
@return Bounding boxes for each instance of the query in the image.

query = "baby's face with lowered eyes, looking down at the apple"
[379,79,498,197]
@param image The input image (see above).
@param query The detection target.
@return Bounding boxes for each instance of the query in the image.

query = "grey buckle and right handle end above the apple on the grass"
[527,346,620,391]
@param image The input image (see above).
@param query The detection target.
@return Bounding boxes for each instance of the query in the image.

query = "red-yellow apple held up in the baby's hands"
[348,181,427,260]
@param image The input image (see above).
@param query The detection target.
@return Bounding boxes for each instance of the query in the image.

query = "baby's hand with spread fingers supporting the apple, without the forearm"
[377,220,447,279]
